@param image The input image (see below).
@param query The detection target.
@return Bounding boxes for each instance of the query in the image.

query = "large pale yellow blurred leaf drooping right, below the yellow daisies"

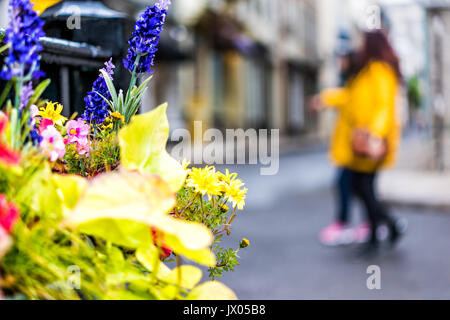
[65,170,215,266]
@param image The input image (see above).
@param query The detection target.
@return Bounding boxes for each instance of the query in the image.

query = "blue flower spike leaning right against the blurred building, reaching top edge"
[123,0,170,73]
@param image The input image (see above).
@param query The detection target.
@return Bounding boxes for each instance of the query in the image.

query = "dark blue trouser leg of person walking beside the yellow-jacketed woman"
[336,168,352,224]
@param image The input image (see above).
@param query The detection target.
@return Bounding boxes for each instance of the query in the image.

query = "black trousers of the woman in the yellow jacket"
[351,171,394,242]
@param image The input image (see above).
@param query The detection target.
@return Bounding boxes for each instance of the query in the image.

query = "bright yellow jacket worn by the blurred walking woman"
[321,61,401,173]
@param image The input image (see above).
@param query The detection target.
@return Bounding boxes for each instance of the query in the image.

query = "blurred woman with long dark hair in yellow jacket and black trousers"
[320,31,402,251]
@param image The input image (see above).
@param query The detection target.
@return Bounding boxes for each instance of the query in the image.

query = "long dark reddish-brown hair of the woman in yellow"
[356,30,403,82]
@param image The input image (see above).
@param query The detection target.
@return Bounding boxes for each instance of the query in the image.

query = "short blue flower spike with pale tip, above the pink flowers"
[82,59,115,124]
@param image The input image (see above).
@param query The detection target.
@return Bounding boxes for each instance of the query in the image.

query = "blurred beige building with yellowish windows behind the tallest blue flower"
[108,0,320,140]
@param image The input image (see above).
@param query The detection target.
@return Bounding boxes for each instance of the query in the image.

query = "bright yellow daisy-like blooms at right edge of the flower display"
[186,166,247,210]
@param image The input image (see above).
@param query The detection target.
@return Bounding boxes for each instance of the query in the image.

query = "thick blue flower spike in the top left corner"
[0,0,45,80]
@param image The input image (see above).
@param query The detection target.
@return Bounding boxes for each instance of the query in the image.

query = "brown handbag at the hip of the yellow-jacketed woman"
[352,128,388,161]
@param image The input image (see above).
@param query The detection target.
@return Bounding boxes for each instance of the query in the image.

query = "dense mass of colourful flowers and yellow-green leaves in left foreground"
[0,0,243,300]
